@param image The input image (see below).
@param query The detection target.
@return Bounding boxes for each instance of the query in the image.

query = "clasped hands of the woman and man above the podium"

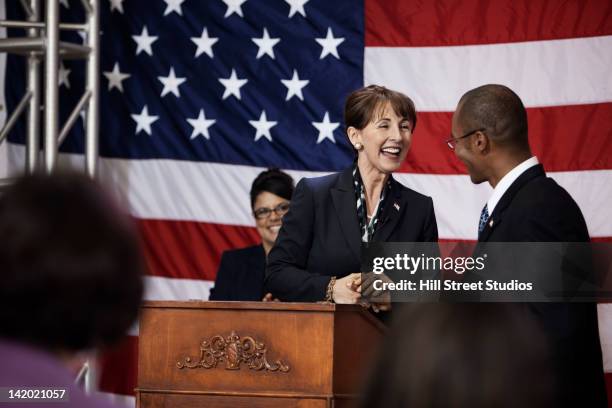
[332,273,391,313]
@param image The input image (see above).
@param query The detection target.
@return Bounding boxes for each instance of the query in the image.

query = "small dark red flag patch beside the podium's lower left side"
[99,336,138,395]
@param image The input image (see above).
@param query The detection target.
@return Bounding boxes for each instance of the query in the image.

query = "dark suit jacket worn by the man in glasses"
[478,165,607,407]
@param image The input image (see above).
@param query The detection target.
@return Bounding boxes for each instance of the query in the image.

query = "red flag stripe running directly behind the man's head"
[400,103,612,174]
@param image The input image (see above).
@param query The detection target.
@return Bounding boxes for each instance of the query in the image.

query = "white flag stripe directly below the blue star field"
[4,144,612,239]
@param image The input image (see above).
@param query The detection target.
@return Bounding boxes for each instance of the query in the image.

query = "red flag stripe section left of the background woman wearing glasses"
[137,219,260,280]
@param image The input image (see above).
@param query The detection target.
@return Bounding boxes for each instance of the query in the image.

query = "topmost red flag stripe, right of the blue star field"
[365,0,612,47]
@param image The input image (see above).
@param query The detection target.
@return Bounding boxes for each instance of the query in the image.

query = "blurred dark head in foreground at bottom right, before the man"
[360,303,554,408]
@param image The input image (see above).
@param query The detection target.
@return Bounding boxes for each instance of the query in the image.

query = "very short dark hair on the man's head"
[458,84,529,149]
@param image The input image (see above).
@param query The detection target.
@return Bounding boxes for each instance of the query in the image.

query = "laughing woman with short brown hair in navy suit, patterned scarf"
[266,85,438,311]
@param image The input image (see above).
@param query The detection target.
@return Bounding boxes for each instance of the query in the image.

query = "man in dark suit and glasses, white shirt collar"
[448,85,606,407]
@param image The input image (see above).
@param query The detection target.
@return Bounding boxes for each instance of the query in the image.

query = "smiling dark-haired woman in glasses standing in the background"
[210,169,293,301]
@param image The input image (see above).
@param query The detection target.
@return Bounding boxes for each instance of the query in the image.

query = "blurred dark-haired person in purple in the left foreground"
[0,173,143,408]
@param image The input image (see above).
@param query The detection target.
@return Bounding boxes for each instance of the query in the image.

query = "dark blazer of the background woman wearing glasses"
[209,245,266,300]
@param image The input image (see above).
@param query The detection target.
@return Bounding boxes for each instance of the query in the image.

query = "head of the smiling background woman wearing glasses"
[250,169,294,254]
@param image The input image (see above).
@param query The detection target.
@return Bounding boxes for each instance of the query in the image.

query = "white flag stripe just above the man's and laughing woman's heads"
[364,36,612,112]
